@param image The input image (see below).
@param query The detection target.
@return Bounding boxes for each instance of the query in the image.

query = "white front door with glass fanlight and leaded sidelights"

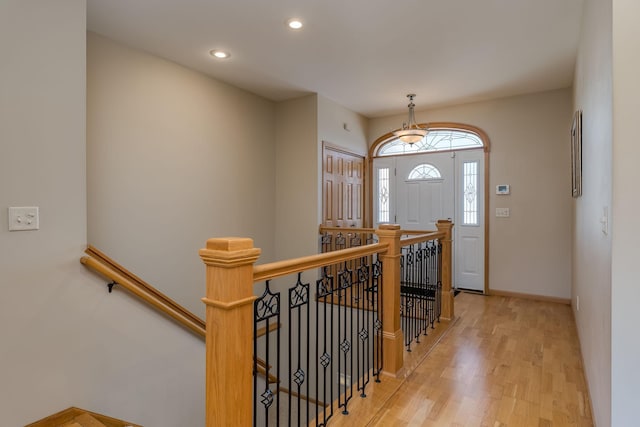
[374,149,484,292]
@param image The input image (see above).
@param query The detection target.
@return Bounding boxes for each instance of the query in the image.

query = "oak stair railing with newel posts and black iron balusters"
[200,221,454,427]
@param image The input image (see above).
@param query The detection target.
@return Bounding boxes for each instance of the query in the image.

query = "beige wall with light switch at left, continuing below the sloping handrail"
[0,0,204,427]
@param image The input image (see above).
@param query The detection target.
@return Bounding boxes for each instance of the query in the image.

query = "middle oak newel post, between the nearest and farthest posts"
[376,224,404,376]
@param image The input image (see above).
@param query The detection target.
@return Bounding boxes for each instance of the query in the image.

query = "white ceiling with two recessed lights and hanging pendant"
[87,0,583,117]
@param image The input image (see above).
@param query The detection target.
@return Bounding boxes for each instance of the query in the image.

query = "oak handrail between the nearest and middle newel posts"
[253,243,389,282]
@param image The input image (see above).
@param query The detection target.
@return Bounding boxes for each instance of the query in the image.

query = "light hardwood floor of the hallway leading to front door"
[329,293,593,427]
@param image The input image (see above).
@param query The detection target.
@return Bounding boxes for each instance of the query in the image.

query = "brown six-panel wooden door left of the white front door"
[322,144,364,227]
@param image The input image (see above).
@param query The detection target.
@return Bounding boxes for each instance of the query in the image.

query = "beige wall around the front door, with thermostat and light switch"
[369,89,572,299]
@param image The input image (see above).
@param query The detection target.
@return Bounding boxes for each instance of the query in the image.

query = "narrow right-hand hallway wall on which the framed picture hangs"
[572,0,612,426]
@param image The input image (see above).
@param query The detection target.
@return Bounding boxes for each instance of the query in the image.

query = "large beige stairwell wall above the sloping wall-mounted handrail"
[87,33,275,316]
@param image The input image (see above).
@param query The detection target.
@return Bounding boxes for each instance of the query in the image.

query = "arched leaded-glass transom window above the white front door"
[377,129,484,156]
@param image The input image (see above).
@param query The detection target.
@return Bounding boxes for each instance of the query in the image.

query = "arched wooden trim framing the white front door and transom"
[364,122,491,295]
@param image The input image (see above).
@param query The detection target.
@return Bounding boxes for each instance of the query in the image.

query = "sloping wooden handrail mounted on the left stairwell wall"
[80,256,206,337]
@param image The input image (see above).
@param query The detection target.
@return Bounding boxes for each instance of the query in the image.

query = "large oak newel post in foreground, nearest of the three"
[200,237,260,427]
